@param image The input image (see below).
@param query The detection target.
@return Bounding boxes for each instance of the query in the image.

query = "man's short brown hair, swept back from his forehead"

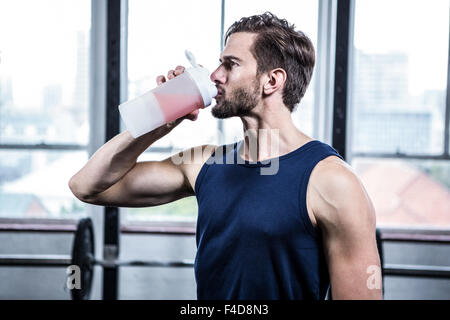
[225,12,315,112]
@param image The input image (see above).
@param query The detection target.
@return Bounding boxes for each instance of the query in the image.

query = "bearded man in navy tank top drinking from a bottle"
[69,13,381,299]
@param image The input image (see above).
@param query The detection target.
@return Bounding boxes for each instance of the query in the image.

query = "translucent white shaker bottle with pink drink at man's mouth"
[119,50,217,138]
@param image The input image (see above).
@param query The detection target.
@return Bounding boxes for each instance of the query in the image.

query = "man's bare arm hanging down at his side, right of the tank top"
[311,159,382,300]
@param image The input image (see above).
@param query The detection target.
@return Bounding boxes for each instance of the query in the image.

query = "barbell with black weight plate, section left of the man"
[0,218,194,300]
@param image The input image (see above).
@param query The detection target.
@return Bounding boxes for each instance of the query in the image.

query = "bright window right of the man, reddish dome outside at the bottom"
[347,0,450,229]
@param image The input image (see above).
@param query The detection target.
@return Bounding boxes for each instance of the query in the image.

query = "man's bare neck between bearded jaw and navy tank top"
[238,100,313,162]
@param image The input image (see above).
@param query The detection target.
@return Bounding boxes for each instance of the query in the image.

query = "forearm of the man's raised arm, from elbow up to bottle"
[69,126,171,198]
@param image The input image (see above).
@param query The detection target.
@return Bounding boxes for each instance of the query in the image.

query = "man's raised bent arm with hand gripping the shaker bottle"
[69,67,211,207]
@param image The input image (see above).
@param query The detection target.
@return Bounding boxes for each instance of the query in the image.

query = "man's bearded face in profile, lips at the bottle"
[211,32,261,119]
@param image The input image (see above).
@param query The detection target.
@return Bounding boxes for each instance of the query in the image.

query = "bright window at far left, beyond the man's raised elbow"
[0,0,91,220]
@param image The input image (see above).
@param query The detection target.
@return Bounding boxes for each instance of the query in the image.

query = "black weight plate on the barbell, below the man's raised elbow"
[70,218,94,300]
